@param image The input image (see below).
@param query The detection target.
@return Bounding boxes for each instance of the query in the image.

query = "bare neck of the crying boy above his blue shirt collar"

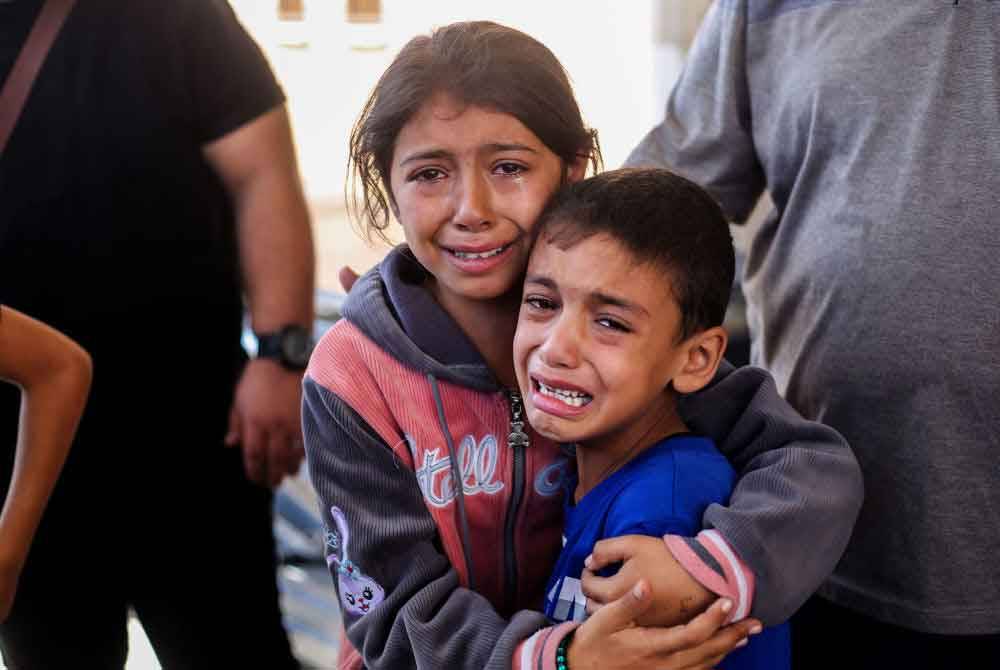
[573,391,687,502]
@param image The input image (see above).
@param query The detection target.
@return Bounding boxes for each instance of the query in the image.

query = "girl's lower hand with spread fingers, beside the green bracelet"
[567,580,760,670]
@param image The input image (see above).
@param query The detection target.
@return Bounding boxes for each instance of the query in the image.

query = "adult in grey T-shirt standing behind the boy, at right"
[627,0,1000,669]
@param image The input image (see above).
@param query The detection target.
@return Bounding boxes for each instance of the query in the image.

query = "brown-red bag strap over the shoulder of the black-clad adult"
[0,0,76,155]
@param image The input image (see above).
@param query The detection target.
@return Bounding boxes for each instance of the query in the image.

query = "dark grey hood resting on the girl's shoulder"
[343,245,503,392]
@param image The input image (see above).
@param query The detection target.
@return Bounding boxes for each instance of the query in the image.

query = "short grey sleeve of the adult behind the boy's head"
[625,0,765,223]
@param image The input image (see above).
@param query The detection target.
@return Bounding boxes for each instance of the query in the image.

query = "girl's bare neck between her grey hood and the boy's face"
[428,278,521,388]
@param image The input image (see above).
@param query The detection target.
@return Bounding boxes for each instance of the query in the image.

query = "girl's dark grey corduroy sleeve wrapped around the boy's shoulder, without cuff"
[680,363,864,625]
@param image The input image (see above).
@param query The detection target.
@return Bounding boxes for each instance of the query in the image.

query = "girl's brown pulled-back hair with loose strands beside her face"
[346,21,601,240]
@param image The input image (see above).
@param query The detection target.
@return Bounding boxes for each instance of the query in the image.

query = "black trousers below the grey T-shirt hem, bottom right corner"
[792,596,1000,670]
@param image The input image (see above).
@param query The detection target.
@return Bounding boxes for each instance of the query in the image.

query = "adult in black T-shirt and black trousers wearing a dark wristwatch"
[0,0,314,669]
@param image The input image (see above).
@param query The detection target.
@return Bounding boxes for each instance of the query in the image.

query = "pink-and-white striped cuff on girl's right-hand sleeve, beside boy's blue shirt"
[663,529,754,623]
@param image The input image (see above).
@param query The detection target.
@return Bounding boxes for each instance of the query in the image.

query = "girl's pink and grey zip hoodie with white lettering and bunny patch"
[303,247,862,669]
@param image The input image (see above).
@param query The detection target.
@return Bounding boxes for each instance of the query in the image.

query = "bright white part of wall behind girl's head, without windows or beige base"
[230,0,662,201]
